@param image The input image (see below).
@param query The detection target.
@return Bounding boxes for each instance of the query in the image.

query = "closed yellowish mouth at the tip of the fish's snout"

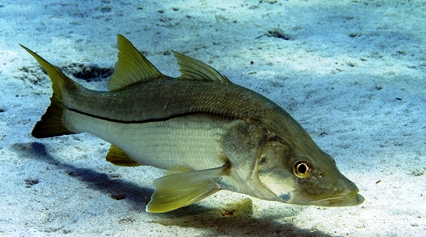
[309,190,365,207]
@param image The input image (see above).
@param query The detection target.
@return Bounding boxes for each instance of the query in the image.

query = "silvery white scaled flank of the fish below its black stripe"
[63,110,234,170]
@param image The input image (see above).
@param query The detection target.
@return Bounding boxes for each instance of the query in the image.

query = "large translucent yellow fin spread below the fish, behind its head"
[146,165,227,213]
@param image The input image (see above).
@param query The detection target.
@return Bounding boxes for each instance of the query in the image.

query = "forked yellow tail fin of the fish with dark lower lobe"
[21,45,77,138]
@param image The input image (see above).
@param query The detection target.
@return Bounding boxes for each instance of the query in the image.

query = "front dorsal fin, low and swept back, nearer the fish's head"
[172,51,231,83]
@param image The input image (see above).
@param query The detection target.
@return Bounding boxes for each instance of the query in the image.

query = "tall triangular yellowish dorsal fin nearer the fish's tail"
[108,34,163,91]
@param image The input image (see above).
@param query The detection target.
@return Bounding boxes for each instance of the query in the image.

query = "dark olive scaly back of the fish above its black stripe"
[64,78,274,123]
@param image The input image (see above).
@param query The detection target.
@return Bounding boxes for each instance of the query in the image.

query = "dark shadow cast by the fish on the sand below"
[12,142,330,236]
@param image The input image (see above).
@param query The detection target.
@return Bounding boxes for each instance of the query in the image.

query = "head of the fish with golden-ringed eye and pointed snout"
[250,138,364,206]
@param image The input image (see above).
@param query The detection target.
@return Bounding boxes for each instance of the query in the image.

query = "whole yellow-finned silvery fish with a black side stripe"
[21,34,364,213]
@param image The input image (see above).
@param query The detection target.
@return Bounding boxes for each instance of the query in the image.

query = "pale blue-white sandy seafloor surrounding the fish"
[0,0,426,236]
